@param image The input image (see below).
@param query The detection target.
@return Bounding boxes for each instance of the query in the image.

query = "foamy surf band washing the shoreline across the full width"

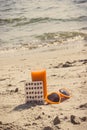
[0,32,87,50]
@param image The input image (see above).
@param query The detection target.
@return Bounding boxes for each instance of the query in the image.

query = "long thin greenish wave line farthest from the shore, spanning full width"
[0,16,87,26]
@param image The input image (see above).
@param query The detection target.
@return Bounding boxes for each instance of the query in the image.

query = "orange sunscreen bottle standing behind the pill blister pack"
[31,70,47,98]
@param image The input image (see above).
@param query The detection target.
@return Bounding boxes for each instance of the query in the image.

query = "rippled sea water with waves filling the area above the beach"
[0,0,87,49]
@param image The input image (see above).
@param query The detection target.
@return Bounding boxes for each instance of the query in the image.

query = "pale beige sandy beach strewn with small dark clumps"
[0,42,87,130]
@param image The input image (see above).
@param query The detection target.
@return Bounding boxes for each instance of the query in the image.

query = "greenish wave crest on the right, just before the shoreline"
[36,32,87,43]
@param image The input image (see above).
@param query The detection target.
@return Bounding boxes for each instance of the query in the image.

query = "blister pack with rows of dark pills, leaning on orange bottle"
[25,81,44,103]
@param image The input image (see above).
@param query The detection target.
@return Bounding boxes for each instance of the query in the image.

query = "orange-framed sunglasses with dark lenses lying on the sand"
[46,88,71,104]
